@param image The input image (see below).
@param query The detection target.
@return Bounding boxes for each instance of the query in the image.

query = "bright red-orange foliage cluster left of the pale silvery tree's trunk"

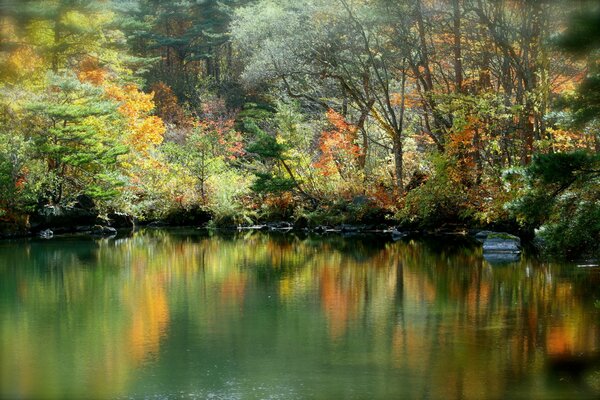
[314,109,361,177]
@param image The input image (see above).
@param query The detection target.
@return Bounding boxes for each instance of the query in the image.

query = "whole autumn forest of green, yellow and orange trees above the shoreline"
[0,0,600,258]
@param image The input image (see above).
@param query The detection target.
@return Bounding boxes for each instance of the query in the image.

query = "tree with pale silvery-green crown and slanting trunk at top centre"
[232,0,406,193]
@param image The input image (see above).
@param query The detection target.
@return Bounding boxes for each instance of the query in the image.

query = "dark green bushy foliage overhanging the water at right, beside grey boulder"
[507,152,600,257]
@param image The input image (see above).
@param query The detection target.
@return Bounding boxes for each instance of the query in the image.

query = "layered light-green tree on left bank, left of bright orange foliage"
[28,75,128,203]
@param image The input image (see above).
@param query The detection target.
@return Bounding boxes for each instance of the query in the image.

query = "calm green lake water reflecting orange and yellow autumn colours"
[0,230,600,399]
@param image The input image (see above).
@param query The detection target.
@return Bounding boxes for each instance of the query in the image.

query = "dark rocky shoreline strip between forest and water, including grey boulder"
[0,195,522,262]
